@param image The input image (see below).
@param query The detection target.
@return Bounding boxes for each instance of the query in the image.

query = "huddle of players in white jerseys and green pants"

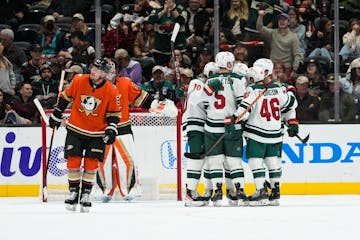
[183,52,298,206]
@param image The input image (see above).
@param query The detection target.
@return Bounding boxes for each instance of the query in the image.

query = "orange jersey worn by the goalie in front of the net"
[115,77,153,126]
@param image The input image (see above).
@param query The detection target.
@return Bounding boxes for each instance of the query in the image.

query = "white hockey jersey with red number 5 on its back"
[205,73,246,133]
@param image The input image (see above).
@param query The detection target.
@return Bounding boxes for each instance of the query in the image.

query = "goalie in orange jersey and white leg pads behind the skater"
[98,60,178,202]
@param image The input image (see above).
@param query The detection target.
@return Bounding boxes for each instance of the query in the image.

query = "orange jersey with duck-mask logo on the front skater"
[61,74,120,137]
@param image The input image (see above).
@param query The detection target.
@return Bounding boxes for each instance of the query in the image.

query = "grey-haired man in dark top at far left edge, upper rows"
[0,29,26,82]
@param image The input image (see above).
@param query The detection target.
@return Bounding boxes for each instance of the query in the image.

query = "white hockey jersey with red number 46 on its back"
[236,84,297,143]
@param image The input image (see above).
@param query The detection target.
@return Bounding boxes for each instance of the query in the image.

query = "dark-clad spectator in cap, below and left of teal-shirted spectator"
[21,43,46,83]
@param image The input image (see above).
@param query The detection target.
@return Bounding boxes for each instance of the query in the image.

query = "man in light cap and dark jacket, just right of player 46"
[295,76,320,122]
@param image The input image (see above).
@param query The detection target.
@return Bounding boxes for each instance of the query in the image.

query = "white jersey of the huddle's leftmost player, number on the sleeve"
[182,78,206,135]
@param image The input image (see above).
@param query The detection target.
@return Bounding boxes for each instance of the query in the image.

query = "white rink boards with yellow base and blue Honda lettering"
[0,124,360,196]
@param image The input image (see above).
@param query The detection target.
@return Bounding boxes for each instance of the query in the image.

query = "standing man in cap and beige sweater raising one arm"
[256,10,303,78]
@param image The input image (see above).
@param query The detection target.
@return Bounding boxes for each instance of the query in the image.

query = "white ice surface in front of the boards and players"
[0,195,360,240]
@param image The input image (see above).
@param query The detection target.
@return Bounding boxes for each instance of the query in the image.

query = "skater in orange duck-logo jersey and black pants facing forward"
[49,59,120,212]
